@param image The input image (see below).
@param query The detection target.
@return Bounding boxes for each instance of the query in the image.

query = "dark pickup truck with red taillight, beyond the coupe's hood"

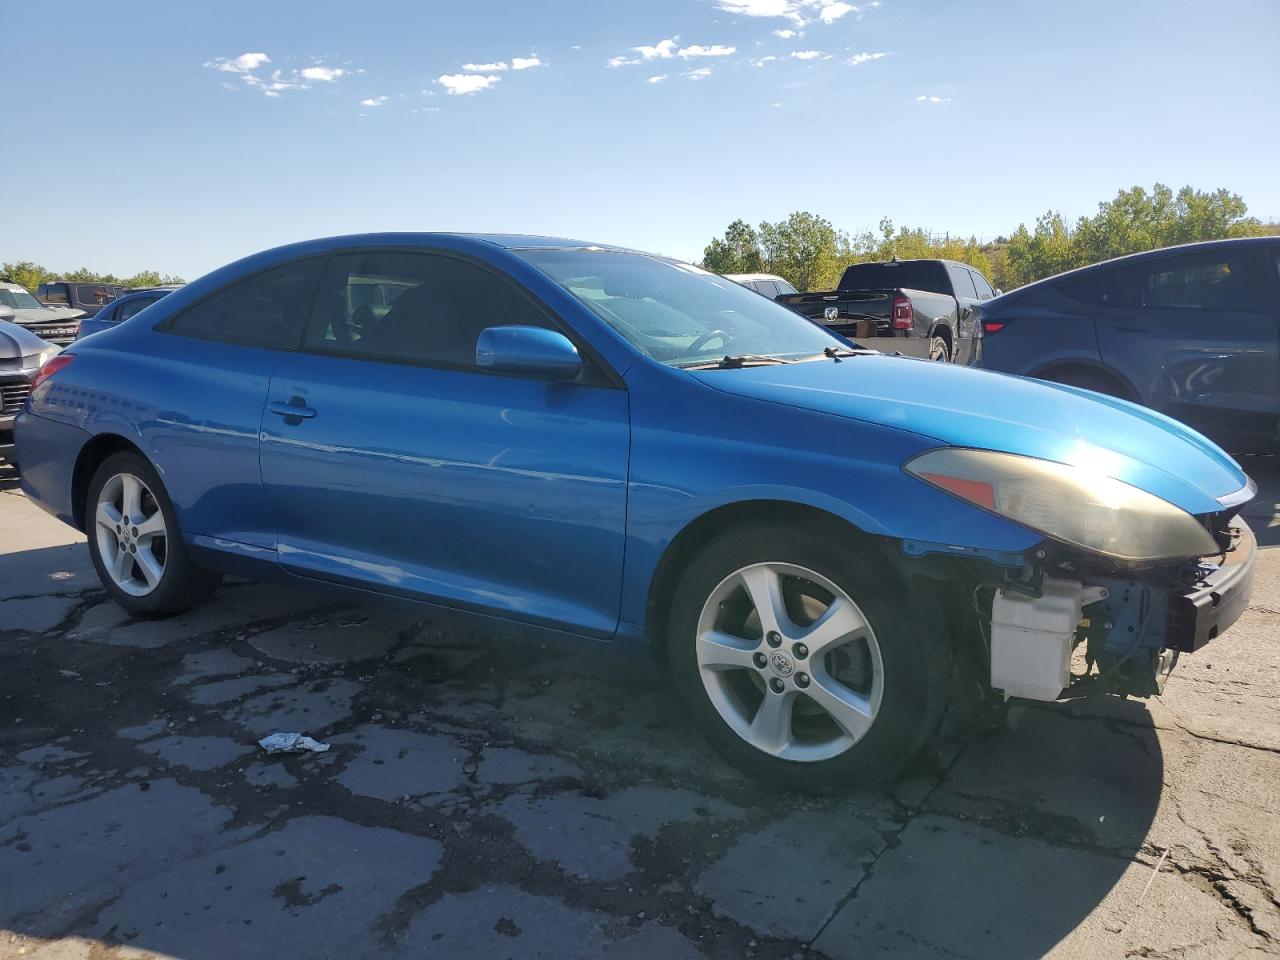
[777,260,996,362]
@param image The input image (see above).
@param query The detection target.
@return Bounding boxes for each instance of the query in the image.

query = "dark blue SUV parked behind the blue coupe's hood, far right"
[973,237,1280,452]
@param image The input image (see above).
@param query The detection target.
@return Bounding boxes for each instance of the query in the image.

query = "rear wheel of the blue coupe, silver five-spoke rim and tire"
[84,453,219,616]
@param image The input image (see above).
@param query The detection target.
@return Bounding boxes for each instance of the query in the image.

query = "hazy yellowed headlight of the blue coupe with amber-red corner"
[905,447,1221,562]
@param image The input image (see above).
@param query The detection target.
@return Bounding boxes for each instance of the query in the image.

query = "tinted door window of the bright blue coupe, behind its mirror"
[305,250,554,367]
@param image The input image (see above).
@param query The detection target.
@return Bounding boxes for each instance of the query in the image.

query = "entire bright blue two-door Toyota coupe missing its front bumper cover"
[17,233,1256,791]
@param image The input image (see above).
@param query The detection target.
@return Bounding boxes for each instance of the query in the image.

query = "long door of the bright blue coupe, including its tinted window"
[261,250,630,636]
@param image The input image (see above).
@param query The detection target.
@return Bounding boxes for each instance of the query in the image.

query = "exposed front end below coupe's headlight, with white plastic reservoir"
[989,520,1257,700]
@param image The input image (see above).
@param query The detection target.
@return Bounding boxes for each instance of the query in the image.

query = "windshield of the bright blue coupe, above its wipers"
[518,250,847,366]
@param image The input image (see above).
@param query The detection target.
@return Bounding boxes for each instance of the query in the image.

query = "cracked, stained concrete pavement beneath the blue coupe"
[0,460,1280,960]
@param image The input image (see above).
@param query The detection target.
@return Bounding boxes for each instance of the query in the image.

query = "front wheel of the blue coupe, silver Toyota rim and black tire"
[667,525,950,794]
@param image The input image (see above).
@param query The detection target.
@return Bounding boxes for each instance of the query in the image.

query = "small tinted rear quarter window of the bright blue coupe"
[165,257,324,349]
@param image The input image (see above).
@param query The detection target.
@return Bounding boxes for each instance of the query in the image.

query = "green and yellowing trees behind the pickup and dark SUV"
[703,183,1280,291]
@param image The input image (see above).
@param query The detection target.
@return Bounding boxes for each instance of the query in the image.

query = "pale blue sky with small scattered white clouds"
[10,0,1280,279]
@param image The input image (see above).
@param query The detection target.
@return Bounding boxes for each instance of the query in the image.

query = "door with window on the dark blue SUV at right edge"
[1094,244,1280,445]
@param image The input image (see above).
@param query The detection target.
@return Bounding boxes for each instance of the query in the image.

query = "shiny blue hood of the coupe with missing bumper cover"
[692,355,1249,513]
